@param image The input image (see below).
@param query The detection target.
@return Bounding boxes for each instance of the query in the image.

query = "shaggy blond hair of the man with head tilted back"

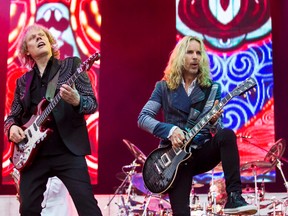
[17,23,60,68]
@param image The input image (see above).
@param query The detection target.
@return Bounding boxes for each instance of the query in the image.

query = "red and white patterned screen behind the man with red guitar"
[2,0,101,185]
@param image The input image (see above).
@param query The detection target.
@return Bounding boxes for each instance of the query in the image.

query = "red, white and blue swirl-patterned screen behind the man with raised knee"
[176,0,275,182]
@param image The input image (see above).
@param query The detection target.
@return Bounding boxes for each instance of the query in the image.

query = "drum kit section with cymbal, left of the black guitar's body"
[107,139,172,216]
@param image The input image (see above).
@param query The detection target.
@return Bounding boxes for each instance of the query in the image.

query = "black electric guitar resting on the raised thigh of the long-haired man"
[142,78,256,193]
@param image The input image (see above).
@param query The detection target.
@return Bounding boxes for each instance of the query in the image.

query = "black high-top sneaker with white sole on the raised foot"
[224,191,257,215]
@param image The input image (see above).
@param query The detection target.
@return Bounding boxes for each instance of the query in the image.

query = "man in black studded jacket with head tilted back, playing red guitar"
[4,24,102,216]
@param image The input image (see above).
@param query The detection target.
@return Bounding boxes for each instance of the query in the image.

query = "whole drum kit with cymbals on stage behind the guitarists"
[107,139,288,216]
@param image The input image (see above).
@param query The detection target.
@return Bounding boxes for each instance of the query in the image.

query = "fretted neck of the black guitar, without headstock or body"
[184,94,233,148]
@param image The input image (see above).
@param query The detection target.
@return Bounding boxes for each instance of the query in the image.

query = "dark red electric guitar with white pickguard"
[10,53,100,170]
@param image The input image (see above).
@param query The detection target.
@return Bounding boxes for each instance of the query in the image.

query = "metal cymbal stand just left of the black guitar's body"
[104,159,136,215]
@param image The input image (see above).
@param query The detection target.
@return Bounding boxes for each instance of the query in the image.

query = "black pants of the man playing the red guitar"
[20,153,102,216]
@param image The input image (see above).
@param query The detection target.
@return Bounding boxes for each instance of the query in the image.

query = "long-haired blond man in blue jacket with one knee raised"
[138,36,257,216]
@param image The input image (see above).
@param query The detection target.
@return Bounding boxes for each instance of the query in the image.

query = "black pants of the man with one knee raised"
[168,129,241,216]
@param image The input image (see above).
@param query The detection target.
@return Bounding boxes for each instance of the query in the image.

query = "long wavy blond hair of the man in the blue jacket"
[163,36,212,90]
